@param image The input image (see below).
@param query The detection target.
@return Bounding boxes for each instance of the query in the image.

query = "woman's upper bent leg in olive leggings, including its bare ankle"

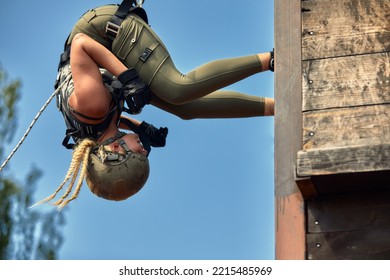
[112,16,270,105]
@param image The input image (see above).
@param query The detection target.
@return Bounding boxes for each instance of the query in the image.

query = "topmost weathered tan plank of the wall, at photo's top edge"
[302,0,390,60]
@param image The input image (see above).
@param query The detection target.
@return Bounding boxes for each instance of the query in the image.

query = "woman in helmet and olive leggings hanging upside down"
[32,0,274,208]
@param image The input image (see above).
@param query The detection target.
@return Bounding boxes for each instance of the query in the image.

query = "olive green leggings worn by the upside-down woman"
[69,5,265,119]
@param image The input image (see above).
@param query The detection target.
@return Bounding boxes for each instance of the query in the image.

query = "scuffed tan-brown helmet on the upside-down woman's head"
[86,134,150,201]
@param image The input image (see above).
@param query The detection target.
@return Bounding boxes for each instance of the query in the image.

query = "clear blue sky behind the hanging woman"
[0,0,275,260]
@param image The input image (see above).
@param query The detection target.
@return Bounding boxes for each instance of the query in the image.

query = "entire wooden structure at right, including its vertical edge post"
[275,0,390,259]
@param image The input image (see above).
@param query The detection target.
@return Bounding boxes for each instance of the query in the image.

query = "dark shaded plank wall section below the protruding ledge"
[306,191,390,260]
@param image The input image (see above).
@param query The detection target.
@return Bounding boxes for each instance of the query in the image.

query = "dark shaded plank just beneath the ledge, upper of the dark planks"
[307,191,390,233]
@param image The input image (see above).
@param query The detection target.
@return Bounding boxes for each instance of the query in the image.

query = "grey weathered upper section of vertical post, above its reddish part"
[275,0,302,196]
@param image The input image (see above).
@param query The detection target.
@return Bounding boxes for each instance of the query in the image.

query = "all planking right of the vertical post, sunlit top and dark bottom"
[298,0,390,260]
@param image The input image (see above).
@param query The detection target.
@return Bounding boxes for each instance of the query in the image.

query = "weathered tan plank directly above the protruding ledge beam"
[303,104,390,150]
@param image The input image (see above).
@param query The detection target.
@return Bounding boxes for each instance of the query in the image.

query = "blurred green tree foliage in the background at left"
[0,65,65,260]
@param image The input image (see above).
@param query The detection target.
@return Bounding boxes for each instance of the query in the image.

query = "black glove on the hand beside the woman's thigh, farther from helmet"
[118,68,150,114]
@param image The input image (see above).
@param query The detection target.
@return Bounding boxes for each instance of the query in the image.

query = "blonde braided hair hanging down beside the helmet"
[31,139,97,211]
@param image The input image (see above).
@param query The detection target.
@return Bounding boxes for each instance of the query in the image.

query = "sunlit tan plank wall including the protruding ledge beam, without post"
[298,0,390,176]
